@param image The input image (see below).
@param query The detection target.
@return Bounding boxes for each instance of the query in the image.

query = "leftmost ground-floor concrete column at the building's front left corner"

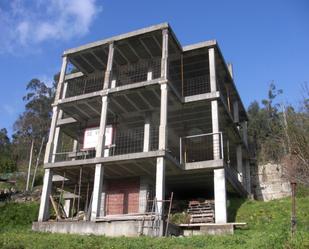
[38,169,53,221]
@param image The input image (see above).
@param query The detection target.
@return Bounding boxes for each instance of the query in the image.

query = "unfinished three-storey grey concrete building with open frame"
[33,23,250,236]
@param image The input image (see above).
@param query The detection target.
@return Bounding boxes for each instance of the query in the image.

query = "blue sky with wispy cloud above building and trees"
[0,0,309,134]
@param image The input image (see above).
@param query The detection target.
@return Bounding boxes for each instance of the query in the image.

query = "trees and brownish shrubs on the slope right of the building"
[248,83,309,186]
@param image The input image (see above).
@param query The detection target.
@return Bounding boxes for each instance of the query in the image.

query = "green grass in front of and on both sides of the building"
[0,196,309,249]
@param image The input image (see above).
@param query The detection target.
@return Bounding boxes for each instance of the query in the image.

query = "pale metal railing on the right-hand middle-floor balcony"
[179,132,224,163]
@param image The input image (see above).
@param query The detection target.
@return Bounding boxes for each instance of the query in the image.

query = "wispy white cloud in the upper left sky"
[0,0,102,53]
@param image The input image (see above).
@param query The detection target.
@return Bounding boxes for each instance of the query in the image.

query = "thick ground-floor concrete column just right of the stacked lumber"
[214,168,227,224]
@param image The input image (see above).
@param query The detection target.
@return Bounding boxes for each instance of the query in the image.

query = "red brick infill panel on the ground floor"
[106,178,140,215]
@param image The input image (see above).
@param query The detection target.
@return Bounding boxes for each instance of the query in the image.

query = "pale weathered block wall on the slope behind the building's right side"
[251,163,291,201]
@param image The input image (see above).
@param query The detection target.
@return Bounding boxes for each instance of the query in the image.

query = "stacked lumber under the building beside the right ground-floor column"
[187,200,215,223]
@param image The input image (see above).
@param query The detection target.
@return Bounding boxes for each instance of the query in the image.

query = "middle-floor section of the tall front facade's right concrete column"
[159,83,168,150]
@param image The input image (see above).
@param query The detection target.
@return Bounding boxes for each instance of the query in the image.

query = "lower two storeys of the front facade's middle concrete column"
[90,96,108,221]
